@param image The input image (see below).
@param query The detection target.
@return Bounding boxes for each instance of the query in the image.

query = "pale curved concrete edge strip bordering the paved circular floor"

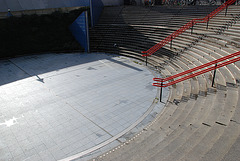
[59,67,171,161]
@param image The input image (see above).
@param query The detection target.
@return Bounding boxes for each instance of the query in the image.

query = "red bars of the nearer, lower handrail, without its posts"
[153,51,240,87]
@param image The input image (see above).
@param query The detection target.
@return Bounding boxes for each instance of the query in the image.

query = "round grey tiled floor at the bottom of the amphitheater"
[0,54,167,161]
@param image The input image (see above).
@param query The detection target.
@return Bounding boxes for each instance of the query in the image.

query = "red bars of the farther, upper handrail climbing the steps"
[142,0,236,57]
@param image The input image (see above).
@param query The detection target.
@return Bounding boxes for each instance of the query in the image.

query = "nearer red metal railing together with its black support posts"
[153,51,240,102]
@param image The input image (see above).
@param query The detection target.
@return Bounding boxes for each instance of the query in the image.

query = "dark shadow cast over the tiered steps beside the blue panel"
[90,6,175,61]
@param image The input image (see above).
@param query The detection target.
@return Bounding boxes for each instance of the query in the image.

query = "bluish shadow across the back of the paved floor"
[0,53,117,86]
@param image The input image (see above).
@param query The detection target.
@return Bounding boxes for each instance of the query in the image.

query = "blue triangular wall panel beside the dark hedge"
[69,12,88,52]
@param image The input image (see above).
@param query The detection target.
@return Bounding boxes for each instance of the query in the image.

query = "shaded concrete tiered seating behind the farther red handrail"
[90,6,214,66]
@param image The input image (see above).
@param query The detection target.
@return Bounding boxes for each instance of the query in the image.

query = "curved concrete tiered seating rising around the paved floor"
[91,3,240,161]
